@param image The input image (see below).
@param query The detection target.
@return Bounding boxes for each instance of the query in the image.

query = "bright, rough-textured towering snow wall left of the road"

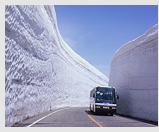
[5,5,108,126]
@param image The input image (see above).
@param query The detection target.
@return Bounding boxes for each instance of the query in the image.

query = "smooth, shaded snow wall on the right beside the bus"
[109,24,158,122]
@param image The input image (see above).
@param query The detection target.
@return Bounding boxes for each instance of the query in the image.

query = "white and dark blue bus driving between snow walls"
[90,86,119,116]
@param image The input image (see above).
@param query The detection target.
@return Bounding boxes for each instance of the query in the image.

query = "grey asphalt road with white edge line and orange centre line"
[14,107,157,127]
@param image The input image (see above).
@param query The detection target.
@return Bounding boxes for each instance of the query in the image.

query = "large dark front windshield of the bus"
[96,87,116,102]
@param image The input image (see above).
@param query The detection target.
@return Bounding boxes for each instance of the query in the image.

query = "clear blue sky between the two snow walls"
[55,5,158,78]
